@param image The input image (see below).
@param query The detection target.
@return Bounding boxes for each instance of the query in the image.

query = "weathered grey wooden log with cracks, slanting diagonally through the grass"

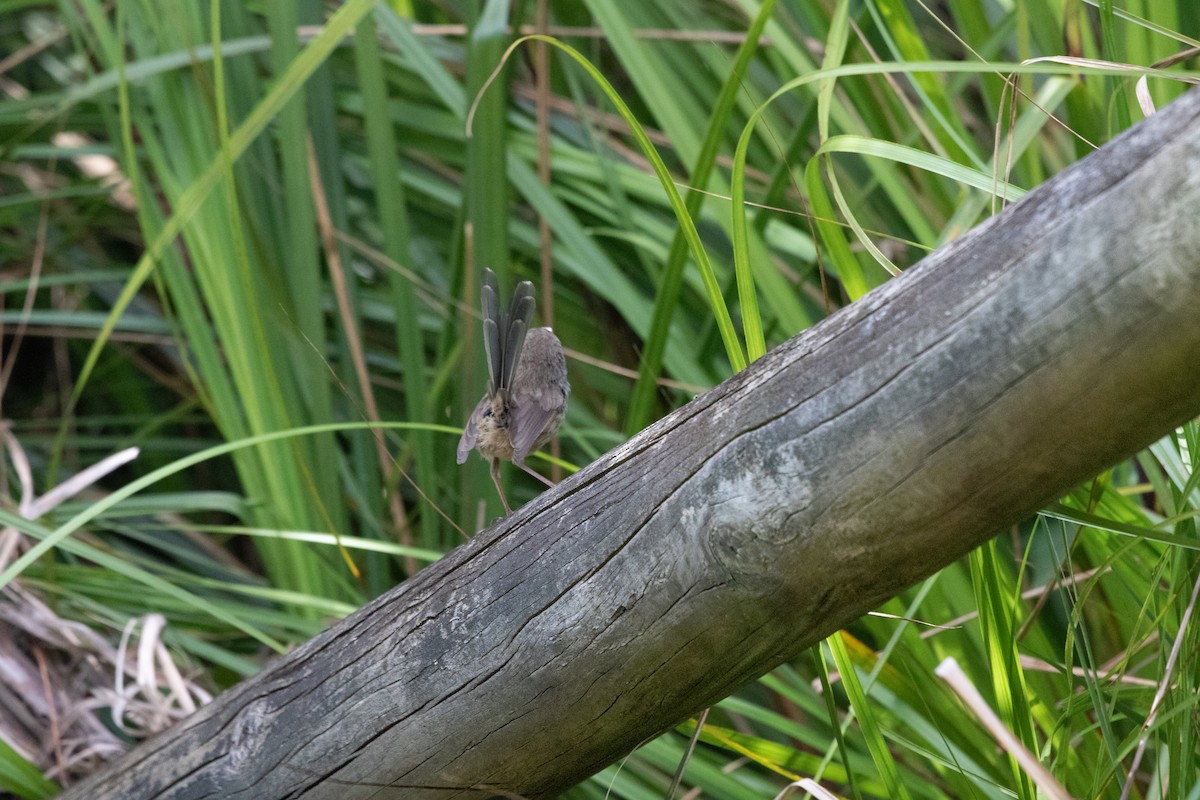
[66,92,1200,800]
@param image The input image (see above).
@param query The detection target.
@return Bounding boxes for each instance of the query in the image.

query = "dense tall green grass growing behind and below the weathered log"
[0,0,1200,800]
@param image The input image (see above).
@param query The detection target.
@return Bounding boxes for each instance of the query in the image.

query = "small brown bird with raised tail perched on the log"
[458,269,571,513]
